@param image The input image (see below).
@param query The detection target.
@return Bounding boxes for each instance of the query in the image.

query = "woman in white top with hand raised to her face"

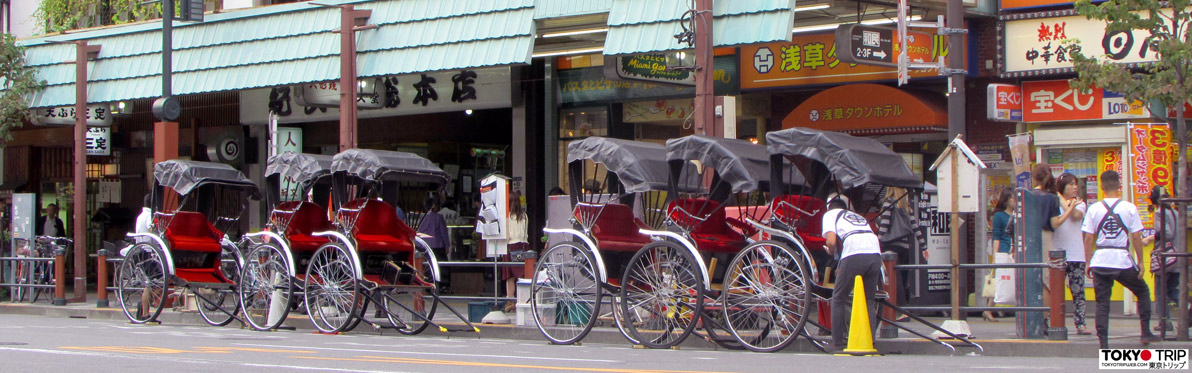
[1051,173,1092,335]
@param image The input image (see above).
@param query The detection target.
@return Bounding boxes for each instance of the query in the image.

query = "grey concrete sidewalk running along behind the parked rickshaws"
[0,294,1192,359]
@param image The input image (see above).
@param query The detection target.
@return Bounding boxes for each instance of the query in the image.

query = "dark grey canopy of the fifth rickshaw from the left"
[666,135,786,192]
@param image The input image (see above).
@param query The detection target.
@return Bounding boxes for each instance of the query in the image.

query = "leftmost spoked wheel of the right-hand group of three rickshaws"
[530,242,603,344]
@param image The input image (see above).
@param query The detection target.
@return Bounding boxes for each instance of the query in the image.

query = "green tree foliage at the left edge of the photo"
[0,33,45,147]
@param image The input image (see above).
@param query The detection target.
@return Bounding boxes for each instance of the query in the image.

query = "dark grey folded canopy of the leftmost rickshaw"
[153,160,261,199]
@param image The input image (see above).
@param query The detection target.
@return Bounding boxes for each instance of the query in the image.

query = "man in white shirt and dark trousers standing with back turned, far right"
[1080,170,1159,348]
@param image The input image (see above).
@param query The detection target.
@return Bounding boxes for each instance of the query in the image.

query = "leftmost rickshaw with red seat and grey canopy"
[116,160,260,327]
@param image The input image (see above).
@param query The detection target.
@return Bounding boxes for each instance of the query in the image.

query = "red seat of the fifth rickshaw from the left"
[666,198,745,253]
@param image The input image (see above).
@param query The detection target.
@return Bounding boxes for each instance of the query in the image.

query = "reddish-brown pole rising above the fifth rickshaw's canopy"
[695,0,719,135]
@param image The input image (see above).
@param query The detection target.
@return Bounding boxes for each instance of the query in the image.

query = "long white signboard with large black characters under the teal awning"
[240,68,513,124]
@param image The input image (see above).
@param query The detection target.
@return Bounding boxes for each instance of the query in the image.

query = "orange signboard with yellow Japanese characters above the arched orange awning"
[740,31,963,89]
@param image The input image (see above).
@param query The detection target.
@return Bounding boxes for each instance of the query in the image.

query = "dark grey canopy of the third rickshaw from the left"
[331,149,451,186]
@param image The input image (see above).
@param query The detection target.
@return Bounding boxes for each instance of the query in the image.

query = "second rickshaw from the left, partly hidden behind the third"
[237,151,334,330]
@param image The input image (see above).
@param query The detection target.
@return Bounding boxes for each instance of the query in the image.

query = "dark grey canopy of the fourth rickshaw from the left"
[567,137,669,193]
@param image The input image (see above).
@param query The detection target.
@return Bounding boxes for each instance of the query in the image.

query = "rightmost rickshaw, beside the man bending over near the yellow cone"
[759,128,981,352]
